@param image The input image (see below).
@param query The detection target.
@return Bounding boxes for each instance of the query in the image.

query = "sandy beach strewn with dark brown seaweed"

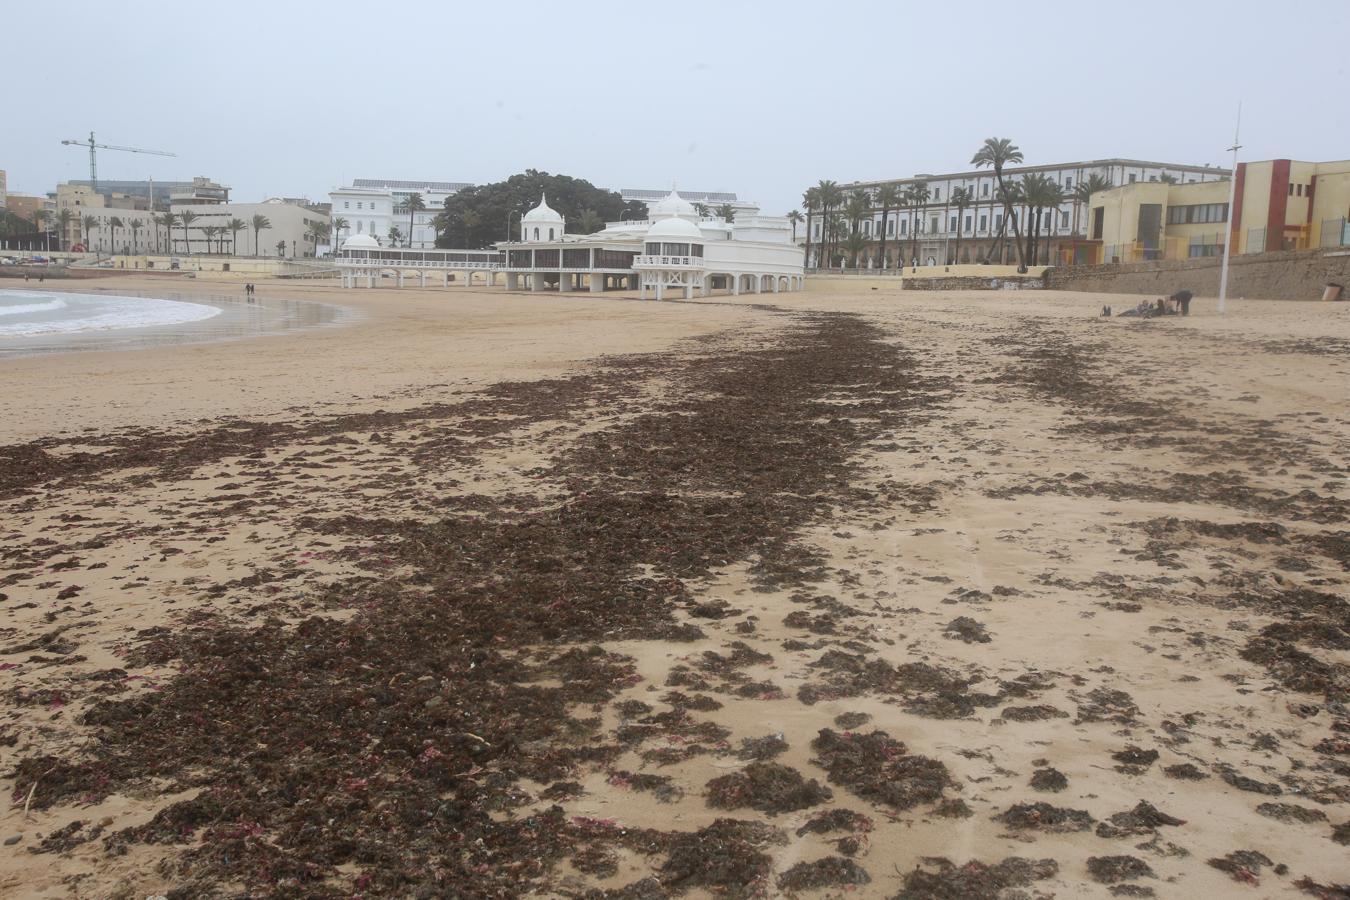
[0,278,1350,899]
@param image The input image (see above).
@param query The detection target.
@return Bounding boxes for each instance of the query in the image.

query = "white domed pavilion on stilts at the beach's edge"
[497,190,805,300]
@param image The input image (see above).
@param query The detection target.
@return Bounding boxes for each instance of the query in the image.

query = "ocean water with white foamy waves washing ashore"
[0,286,354,359]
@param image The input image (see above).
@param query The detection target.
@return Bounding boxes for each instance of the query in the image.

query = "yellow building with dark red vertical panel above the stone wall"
[1088,159,1350,262]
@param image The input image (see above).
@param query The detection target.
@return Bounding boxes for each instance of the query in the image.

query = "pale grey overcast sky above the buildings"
[0,0,1350,213]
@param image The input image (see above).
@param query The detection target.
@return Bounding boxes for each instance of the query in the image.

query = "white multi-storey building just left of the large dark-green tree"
[328,178,473,250]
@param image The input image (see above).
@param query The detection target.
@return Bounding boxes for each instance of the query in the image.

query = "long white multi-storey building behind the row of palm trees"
[815,159,1229,269]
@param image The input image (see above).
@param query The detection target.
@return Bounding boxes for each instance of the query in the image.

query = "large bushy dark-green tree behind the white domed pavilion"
[436,169,647,250]
